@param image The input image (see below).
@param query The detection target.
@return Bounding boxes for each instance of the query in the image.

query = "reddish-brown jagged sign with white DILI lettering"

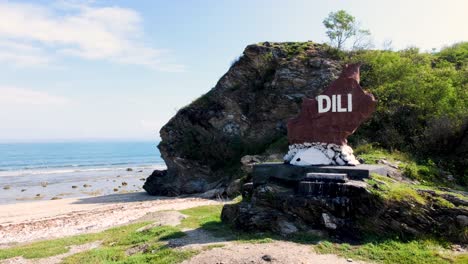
[288,64,377,145]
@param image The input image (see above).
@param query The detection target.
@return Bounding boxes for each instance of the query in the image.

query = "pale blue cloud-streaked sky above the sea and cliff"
[0,0,468,142]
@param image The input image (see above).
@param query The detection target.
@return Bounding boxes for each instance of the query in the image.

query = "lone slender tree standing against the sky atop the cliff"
[323,10,370,49]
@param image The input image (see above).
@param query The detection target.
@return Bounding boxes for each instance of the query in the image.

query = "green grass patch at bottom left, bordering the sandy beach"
[0,223,195,263]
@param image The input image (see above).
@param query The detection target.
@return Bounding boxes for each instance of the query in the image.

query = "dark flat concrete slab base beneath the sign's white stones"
[252,163,387,186]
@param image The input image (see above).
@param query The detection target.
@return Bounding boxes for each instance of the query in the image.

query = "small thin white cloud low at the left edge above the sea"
[0,86,69,106]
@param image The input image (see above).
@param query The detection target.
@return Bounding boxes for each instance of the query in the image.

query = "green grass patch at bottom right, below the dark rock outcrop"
[315,239,460,263]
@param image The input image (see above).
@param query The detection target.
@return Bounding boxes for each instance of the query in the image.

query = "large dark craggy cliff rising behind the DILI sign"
[144,42,342,195]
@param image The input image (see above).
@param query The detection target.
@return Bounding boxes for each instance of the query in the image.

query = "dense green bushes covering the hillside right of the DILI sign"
[345,42,468,186]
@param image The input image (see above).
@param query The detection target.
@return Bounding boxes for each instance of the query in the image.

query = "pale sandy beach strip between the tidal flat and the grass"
[0,193,221,247]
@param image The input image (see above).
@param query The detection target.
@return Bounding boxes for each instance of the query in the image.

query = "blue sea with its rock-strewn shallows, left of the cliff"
[0,141,165,203]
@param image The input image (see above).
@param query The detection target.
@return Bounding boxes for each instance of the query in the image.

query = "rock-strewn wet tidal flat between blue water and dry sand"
[0,165,165,205]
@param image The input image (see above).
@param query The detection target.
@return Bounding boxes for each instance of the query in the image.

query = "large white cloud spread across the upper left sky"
[0,1,183,71]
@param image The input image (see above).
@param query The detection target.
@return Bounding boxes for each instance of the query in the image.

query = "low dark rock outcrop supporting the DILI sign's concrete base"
[222,165,468,243]
